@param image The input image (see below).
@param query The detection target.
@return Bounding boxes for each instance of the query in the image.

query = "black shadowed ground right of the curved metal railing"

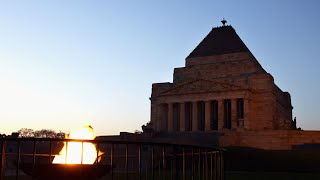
[226,147,320,180]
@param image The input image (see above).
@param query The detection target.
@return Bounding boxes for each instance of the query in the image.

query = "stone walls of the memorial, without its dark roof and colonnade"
[151,49,292,131]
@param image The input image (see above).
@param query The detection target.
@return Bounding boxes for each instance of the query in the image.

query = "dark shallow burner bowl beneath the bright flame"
[21,164,110,180]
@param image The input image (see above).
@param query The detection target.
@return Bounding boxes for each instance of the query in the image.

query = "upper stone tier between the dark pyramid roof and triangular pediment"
[173,53,265,83]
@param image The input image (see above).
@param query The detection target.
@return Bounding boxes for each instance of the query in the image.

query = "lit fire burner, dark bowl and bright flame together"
[21,126,110,180]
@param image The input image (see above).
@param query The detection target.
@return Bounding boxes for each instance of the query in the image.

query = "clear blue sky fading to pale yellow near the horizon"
[0,0,320,135]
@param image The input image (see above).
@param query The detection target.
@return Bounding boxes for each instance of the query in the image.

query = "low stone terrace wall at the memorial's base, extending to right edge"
[219,130,320,150]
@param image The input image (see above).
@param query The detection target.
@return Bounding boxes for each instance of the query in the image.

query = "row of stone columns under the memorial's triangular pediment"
[156,98,248,132]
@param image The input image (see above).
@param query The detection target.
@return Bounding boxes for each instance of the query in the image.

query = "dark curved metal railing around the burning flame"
[0,138,225,180]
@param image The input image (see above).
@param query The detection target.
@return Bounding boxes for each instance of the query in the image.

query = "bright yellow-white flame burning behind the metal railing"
[52,126,103,164]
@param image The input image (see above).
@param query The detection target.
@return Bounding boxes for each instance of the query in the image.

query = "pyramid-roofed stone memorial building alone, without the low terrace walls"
[150,21,295,133]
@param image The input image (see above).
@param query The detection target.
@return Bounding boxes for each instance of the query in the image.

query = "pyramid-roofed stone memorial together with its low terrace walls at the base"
[100,20,320,150]
